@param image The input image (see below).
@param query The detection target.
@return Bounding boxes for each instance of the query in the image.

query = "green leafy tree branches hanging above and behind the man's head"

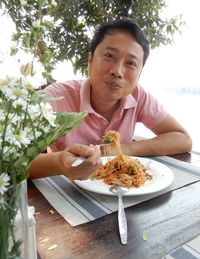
[0,0,184,79]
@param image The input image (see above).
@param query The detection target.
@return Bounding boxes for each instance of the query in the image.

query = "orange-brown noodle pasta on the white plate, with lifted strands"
[93,131,152,187]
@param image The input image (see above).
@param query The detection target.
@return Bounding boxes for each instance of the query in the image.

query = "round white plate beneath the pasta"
[74,157,174,196]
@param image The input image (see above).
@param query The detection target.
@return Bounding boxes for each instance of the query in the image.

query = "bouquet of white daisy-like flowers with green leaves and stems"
[0,69,86,258]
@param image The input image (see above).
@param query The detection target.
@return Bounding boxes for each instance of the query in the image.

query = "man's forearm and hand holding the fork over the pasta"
[28,144,101,180]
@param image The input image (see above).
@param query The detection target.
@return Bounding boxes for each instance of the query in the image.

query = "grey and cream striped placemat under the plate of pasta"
[33,156,200,226]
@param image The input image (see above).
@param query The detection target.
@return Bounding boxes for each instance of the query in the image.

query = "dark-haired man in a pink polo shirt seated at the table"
[30,19,192,181]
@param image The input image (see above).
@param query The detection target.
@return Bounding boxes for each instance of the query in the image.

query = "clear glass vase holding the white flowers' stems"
[0,180,30,259]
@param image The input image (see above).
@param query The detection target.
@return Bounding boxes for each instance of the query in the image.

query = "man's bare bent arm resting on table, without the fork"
[121,115,192,156]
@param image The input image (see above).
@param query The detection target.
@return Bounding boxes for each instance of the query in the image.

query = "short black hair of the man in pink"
[90,18,149,66]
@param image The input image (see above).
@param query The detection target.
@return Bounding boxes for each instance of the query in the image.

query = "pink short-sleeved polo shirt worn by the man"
[45,79,167,151]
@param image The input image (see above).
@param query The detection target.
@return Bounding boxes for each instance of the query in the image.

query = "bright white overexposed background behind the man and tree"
[0,0,200,152]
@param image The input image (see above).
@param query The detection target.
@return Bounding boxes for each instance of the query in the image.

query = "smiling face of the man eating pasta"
[88,30,144,103]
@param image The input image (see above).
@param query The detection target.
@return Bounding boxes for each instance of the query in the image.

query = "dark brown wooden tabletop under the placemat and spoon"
[28,153,200,259]
